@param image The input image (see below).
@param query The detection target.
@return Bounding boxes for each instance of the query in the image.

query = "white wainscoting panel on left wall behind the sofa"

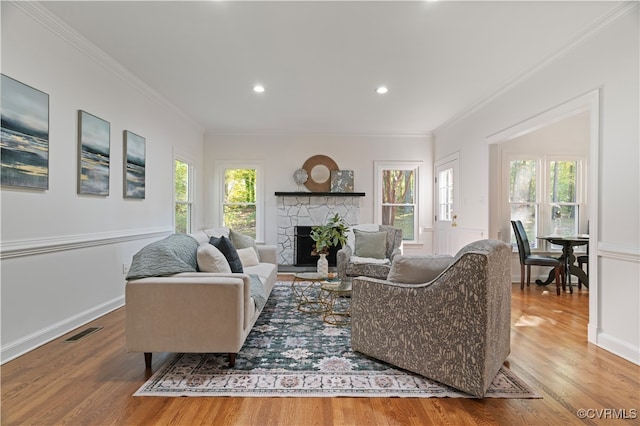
[0,227,173,363]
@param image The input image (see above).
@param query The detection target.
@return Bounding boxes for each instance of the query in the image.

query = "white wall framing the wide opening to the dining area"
[434,3,640,363]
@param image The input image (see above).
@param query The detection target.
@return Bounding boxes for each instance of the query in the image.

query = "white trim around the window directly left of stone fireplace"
[213,160,265,242]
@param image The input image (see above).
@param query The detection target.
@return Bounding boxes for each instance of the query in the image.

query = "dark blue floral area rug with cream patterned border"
[134,282,539,398]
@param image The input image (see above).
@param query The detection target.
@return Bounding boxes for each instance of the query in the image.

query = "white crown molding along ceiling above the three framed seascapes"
[8,1,204,133]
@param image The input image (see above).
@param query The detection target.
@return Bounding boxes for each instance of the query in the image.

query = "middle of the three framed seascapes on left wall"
[78,110,111,196]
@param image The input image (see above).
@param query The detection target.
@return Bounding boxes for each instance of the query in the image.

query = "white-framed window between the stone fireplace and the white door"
[376,162,419,241]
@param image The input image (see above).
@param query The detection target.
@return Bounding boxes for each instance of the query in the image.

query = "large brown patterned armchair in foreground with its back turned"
[351,240,511,397]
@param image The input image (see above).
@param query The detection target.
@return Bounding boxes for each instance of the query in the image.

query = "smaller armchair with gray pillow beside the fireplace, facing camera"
[336,224,402,279]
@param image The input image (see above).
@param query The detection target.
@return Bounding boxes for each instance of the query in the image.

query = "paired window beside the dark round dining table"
[508,156,584,248]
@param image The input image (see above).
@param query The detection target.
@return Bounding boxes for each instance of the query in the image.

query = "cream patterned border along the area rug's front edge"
[133,283,541,399]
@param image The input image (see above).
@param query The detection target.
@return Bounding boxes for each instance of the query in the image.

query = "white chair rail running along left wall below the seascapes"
[0,227,173,259]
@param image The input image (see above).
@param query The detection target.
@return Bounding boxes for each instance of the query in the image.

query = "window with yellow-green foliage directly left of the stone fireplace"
[215,161,264,241]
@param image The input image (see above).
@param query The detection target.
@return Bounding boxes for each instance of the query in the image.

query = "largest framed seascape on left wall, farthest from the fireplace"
[0,74,49,190]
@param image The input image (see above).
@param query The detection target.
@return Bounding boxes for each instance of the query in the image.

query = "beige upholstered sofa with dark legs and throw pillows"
[125,228,277,368]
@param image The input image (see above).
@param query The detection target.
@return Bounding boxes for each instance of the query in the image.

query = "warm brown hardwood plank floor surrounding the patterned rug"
[1,276,640,425]
